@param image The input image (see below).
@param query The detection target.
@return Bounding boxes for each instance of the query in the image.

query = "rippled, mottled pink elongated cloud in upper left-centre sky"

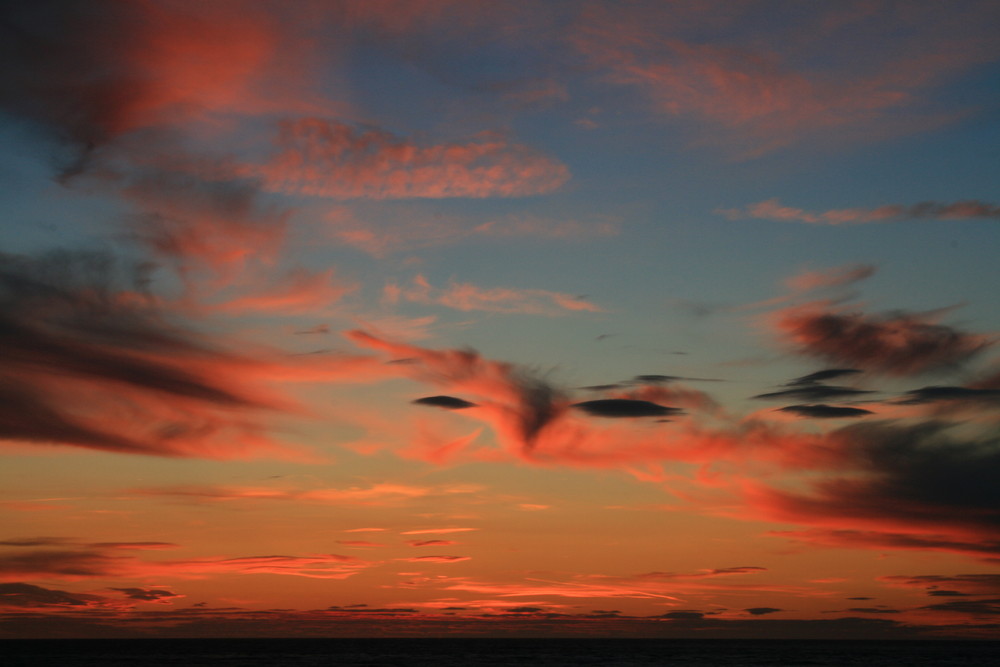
[233,118,569,199]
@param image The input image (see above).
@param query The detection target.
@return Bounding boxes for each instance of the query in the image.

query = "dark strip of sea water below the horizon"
[0,639,1000,667]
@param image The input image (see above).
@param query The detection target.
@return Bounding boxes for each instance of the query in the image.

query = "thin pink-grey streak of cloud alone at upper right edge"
[716,199,1000,225]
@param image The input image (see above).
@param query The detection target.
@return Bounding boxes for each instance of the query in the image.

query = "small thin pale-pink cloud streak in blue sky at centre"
[385,275,603,315]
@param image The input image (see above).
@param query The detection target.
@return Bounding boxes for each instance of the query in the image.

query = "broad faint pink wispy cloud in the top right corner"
[573,2,1000,158]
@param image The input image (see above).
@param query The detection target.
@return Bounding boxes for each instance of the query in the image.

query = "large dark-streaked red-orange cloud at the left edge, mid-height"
[0,253,320,458]
